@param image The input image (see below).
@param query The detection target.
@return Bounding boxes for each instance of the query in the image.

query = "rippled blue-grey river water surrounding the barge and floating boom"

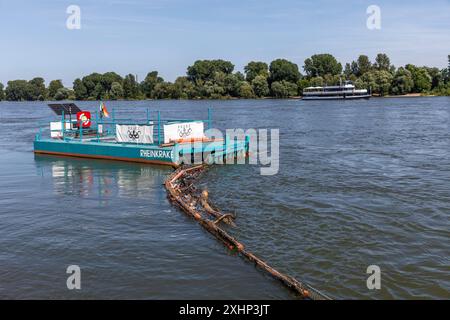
[0,98,450,299]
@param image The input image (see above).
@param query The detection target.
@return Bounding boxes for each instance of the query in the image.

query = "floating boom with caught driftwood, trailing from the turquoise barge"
[165,164,329,300]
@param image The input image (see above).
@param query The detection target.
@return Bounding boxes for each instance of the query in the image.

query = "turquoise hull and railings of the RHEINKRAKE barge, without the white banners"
[34,107,249,167]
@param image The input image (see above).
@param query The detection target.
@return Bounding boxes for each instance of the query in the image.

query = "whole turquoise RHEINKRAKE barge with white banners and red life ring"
[34,104,249,167]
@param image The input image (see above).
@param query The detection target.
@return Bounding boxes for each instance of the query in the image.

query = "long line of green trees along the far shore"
[0,53,450,101]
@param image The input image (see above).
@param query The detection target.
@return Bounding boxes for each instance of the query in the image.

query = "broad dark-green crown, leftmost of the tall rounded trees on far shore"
[187,59,234,82]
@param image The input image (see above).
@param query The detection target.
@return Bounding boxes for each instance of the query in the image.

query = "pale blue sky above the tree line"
[0,0,450,86]
